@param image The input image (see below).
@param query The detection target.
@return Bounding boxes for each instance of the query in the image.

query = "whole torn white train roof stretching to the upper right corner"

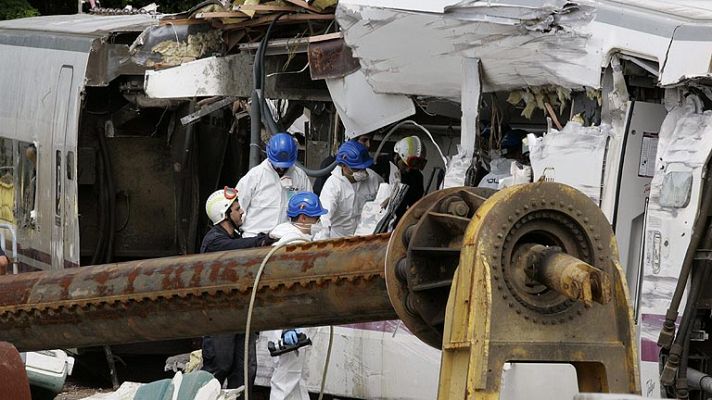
[336,0,712,99]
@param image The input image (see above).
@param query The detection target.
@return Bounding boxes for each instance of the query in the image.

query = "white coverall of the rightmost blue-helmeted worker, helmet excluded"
[318,166,383,239]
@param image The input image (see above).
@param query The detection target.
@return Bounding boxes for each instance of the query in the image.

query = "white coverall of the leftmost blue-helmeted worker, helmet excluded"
[237,159,312,237]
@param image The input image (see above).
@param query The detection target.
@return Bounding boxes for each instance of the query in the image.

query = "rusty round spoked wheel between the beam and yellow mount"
[386,187,495,348]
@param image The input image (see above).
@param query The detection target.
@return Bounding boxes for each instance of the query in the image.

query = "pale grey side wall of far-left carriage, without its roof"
[0,42,91,269]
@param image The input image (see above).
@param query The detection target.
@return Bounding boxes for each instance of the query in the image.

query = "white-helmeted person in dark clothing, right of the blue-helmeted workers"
[393,136,428,224]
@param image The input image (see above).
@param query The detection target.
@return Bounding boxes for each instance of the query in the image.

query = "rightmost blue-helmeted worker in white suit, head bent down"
[319,141,383,239]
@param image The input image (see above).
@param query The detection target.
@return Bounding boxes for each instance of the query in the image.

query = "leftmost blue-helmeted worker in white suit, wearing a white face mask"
[237,133,311,237]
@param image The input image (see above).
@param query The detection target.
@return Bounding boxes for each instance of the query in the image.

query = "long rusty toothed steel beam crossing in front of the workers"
[0,235,397,351]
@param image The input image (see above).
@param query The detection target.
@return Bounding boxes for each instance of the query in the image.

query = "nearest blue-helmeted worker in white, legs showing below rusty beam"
[266,192,327,400]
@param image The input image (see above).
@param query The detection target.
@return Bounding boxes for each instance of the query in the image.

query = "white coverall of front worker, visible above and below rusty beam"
[264,222,312,400]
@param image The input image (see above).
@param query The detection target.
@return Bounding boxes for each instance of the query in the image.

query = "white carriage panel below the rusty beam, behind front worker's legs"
[256,321,440,400]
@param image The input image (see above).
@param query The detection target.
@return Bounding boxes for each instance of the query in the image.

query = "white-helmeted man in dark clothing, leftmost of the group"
[200,186,274,390]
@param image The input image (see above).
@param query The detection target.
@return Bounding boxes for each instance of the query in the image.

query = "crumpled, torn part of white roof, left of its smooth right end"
[336,0,601,99]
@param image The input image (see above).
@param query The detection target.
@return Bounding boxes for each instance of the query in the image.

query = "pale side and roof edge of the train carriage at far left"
[0,15,152,269]
